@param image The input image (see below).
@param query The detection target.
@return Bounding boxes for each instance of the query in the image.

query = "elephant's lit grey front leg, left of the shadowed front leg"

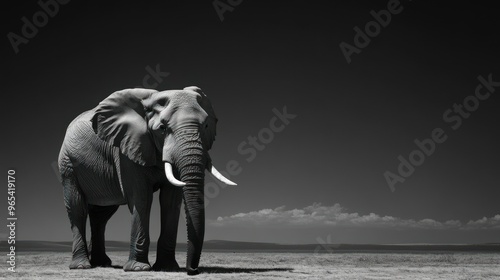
[123,190,153,271]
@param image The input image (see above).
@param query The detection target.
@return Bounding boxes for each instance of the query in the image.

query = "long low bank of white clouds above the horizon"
[210,203,500,230]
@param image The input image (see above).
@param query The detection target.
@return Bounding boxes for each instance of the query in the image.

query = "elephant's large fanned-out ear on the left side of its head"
[92,89,157,166]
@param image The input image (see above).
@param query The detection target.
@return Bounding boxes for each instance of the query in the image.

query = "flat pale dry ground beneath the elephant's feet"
[0,252,500,280]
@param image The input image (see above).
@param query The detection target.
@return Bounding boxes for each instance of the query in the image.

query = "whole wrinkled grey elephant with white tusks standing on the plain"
[58,86,236,275]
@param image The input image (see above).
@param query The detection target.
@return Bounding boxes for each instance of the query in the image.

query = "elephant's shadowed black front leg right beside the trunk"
[153,186,182,271]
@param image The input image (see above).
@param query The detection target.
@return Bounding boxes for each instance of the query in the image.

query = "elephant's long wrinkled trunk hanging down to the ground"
[170,130,208,275]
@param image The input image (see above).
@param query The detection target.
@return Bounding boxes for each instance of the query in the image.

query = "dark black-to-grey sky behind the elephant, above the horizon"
[0,0,500,243]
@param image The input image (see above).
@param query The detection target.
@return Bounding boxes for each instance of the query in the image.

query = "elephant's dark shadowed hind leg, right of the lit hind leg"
[89,205,118,267]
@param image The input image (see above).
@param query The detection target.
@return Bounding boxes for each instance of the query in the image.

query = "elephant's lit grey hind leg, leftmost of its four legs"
[60,164,91,269]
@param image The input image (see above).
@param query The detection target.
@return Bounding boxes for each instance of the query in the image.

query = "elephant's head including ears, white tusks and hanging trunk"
[92,87,235,274]
